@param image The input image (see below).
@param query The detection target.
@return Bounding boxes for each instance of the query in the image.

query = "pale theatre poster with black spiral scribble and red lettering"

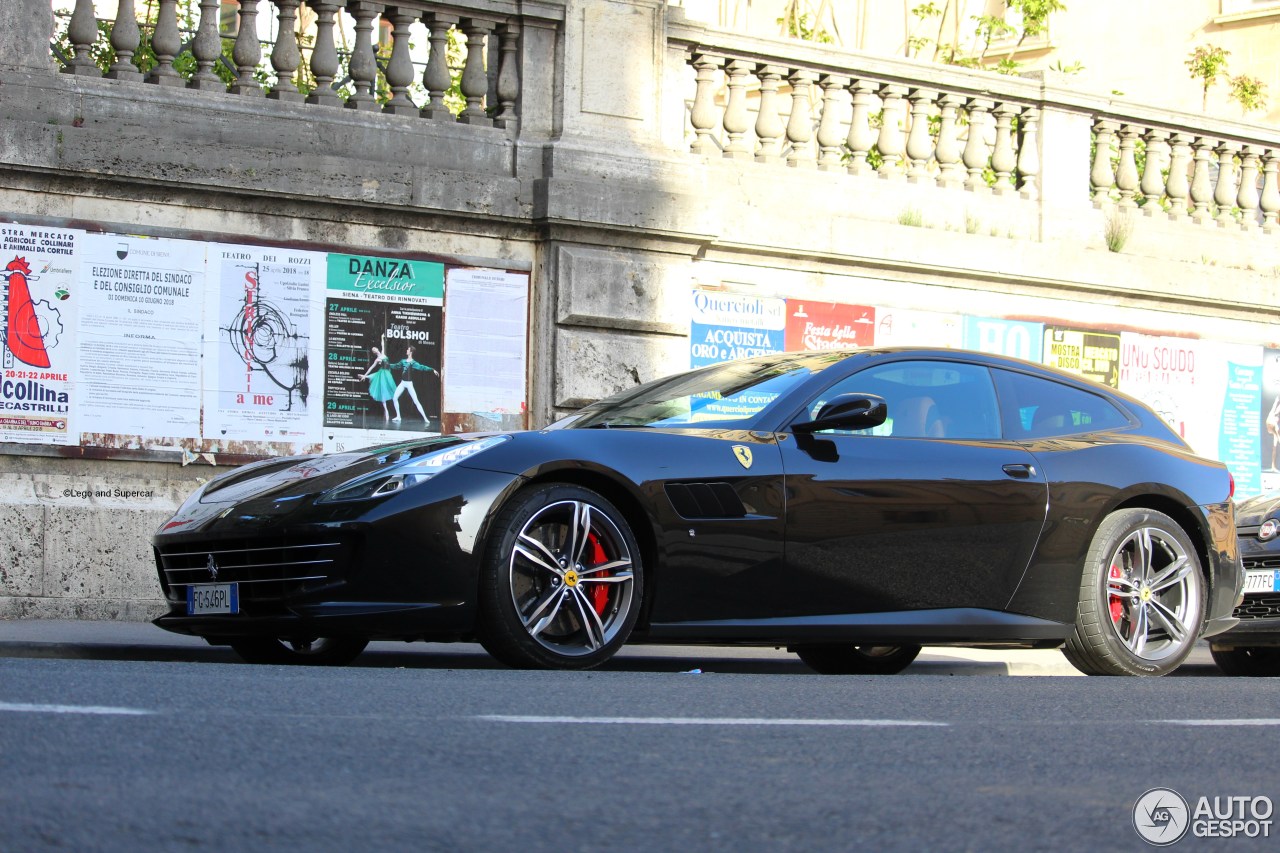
[204,243,325,452]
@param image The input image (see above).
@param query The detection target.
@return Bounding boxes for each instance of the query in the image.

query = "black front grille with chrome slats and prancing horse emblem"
[156,538,351,610]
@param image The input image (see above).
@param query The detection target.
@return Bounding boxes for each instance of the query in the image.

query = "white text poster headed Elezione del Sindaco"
[77,234,205,447]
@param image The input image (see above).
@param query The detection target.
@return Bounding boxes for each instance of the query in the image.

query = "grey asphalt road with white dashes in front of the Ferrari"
[0,645,1280,853]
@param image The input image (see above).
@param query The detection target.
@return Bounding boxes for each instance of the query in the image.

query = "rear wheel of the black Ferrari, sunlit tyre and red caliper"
[1062,507,1206,675]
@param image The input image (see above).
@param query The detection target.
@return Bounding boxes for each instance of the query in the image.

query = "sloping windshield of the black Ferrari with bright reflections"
[556,352,849,429]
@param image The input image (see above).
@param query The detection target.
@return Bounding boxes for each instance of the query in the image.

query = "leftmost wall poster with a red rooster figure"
[0,224,84,444]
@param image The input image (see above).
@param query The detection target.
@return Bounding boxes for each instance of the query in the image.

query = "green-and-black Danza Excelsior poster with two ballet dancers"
[324,254,444,451]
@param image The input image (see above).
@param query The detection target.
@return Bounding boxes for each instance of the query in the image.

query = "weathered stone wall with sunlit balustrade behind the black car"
[0,0,1280,619]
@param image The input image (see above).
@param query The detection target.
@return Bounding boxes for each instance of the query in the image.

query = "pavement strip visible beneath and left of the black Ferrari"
[0,620,1220,676]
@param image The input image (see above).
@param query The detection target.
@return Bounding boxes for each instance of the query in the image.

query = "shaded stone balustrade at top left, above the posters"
[55,0,521,128]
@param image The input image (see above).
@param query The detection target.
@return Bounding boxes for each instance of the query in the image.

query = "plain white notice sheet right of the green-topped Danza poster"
[444,268,529,433]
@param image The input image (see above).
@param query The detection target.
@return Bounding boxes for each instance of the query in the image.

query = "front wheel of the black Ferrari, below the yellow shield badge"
[479,483,644,670]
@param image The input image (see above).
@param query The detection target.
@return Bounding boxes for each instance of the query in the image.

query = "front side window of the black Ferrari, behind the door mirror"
[809,361,1000,438]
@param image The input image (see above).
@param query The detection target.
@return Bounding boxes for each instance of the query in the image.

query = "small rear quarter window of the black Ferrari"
[992,369,1129,438]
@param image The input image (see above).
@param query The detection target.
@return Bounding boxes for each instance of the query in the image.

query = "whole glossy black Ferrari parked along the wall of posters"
[154,348,1243,675]
